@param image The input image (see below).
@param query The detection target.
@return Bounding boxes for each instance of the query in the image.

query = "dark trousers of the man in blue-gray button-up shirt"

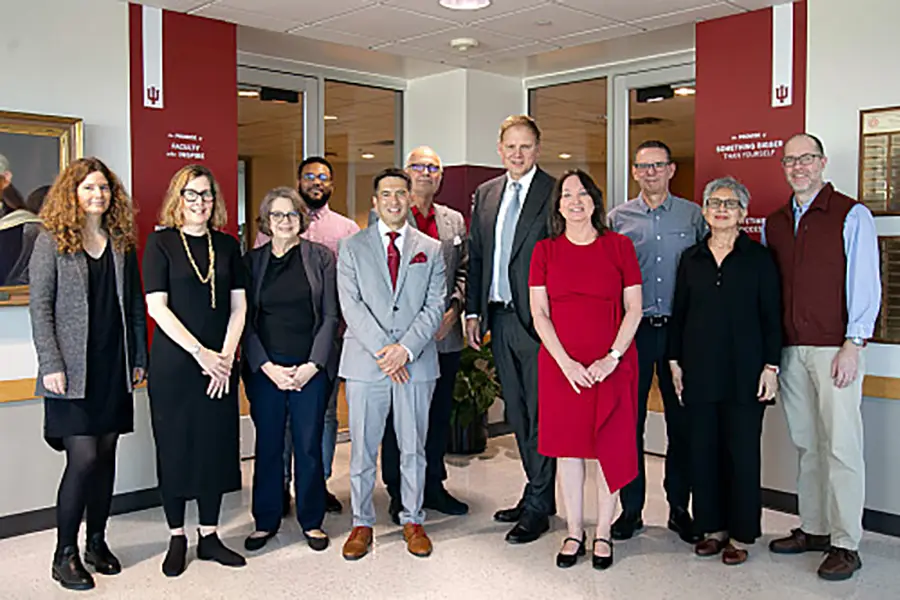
[621,319,691,515]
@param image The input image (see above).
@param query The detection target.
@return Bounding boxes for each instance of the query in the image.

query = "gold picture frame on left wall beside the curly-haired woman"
[0,111,84,306]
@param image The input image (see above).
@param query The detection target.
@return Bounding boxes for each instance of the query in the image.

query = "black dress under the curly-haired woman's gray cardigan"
[44,242,134,451]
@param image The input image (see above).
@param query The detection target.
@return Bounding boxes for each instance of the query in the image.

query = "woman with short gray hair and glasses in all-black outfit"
[669,177,781,565]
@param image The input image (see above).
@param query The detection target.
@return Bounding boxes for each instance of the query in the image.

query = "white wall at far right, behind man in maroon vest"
[763,0,900,514]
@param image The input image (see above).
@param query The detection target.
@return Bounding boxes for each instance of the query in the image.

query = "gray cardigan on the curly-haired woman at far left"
[28,228,147,398]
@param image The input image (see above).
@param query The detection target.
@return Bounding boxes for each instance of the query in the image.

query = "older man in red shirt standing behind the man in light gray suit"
[369,146,469,525]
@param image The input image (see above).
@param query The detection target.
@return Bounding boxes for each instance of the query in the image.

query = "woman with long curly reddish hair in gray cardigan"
[29,158,147,590]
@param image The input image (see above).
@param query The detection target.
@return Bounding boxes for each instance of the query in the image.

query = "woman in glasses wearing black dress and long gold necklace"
[144,165,247,577]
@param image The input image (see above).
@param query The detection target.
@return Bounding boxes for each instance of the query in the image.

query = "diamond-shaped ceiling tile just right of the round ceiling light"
[477,5,615,40]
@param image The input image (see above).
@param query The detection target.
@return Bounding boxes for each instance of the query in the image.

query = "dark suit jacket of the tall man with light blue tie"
[466,167,556,339]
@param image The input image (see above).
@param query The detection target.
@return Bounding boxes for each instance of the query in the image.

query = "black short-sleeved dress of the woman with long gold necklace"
[144,229,246,499]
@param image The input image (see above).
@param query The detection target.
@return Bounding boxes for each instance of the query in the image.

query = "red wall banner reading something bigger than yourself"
[695,0,806,235]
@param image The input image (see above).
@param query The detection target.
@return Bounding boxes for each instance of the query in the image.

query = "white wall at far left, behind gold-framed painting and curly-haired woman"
[0,0,156,516]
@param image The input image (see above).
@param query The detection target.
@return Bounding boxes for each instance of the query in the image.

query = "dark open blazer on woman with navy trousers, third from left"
[242,238,340,379]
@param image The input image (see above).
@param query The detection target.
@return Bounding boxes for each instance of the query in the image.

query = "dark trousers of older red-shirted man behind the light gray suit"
[381,352,462,500]
